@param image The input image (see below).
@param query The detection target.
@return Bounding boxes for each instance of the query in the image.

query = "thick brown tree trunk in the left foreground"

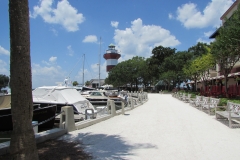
[9,0,38,160]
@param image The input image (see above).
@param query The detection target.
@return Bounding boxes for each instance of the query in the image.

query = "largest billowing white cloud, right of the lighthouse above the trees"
[114,18,180,60]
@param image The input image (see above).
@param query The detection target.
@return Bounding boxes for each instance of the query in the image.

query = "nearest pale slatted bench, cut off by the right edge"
[215,101,240,128]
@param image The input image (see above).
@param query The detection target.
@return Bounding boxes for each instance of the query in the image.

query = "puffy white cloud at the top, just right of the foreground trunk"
[30,0,85,32]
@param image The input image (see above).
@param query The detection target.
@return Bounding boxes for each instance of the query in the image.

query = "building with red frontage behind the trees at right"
[198,0,240,97]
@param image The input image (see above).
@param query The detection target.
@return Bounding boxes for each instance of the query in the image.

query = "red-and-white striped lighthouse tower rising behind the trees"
[103,44,121,72]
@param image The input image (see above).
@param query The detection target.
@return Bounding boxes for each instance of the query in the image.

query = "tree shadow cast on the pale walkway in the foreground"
[61,133,157,159]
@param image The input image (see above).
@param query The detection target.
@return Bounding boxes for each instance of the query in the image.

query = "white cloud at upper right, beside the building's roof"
[176,0,233,28]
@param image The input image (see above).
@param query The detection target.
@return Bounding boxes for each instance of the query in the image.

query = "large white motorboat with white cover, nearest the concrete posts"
[32,86,97,121]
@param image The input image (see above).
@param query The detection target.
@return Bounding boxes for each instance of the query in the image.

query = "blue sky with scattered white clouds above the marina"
[0,0,234,88]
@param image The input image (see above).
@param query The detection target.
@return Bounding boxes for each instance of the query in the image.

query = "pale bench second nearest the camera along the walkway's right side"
[201,97,220,115]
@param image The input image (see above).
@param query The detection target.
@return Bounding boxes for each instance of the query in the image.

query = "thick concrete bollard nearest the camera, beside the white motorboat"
[59,106,76,132]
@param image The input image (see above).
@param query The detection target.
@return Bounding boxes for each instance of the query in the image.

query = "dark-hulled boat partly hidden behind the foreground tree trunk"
[0,94,57,132]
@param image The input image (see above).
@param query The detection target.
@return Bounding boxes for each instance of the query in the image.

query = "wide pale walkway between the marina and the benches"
[61,94,240,160]
